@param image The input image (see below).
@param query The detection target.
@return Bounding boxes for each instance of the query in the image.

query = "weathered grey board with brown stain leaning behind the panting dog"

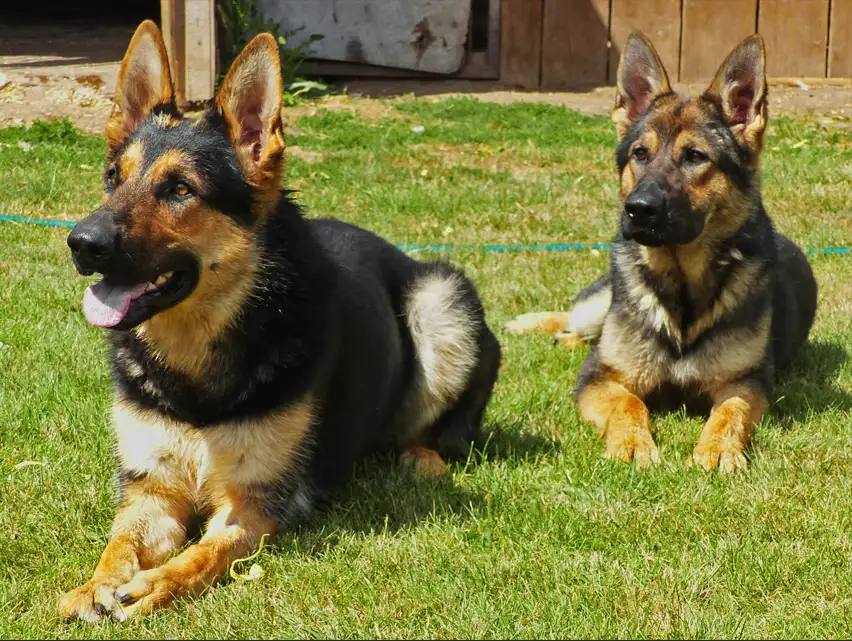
[257,0,471,74]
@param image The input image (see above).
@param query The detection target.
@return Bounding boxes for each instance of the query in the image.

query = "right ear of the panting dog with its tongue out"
[216,33,285,193]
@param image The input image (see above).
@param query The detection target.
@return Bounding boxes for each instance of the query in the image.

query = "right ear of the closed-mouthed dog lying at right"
[704,34,769,152]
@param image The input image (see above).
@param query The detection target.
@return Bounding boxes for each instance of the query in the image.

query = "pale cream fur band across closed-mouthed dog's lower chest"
[600,309,772,394]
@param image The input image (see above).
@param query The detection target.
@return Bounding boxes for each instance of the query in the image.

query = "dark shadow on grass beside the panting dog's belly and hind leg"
[279,425,559,555]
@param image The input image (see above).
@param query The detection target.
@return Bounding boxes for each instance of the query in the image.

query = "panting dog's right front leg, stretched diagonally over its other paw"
[105,495,275,620]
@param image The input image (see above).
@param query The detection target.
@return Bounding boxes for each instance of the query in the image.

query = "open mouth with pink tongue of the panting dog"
[83,269,198,329]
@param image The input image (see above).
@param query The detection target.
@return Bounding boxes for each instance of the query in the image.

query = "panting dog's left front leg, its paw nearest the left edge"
[59,477,192,623]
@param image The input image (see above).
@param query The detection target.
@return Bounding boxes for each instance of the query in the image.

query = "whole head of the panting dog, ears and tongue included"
[68,25,284,329]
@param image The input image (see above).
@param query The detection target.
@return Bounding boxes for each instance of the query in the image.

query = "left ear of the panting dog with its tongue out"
[107,20,175,149]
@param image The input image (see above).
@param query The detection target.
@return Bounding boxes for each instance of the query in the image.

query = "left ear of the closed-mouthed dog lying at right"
[612,31,672,139]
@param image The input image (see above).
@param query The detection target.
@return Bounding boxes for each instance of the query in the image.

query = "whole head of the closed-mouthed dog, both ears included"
[612,34,766,247]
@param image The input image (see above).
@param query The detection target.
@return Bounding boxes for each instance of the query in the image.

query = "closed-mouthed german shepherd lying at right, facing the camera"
[506,33,817,472]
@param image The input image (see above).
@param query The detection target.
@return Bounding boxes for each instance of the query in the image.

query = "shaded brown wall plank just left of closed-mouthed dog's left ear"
[541,0,609,89]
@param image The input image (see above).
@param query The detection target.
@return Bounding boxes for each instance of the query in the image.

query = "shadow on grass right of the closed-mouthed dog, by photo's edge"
[771,341,852,429]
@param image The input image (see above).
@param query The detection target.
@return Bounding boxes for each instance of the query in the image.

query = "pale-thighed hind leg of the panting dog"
[402,263,500,476]
